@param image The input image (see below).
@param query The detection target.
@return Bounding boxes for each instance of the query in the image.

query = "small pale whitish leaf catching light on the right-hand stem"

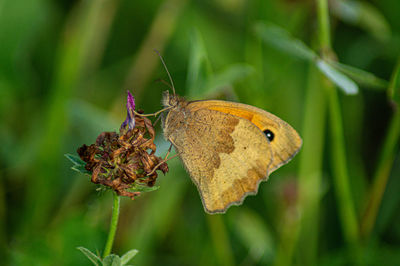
[316,59,358,94]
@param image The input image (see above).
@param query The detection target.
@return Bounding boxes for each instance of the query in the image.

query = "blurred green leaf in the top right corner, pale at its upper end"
[332,0,391,41]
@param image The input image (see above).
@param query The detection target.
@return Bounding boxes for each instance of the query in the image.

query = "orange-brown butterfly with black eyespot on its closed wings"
[163,92,301,213]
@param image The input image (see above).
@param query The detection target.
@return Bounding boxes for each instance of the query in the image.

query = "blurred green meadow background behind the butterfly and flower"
[0,0,400,265]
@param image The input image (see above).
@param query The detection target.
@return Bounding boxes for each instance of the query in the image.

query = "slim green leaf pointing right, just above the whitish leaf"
[326,61,389,89]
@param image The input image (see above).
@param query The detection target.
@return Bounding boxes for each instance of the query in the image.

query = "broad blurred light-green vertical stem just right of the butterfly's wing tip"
[298,65,327,265]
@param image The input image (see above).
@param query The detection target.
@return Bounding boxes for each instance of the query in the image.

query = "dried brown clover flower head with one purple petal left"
[77,91,168,199]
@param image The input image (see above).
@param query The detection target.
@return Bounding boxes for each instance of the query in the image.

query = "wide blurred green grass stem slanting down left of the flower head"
[26,0,116,230]
